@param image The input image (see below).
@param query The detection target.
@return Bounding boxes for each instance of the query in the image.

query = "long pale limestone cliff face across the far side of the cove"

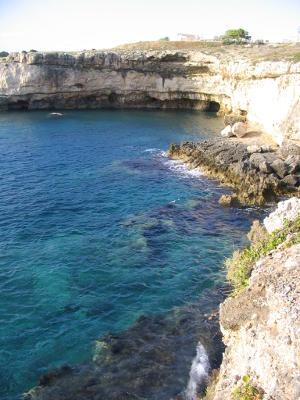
[0,50,300,143]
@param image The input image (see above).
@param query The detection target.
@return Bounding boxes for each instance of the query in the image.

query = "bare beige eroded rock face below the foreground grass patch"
[214,244,300,400]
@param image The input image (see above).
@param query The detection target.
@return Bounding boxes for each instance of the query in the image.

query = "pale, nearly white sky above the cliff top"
[0,0,300,51]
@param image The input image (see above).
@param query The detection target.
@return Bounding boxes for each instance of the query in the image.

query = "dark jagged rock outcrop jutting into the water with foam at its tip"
[169,139,300,204]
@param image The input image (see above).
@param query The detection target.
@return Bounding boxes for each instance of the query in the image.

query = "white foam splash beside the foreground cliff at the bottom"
[185,342,210,400]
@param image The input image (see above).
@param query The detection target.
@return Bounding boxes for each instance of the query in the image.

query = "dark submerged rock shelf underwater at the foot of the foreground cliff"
[24,289,224,400]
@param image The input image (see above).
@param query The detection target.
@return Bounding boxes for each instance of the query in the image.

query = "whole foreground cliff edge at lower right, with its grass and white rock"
[206,198,300,400]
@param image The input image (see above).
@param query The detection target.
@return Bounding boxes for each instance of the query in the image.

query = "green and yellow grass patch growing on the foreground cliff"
[225,216,300,296]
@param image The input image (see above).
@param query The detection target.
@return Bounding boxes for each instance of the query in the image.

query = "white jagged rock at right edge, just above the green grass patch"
[264,197,300,233]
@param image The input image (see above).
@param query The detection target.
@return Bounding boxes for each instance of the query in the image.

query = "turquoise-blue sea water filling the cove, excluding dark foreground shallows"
[0,111,259,399]
